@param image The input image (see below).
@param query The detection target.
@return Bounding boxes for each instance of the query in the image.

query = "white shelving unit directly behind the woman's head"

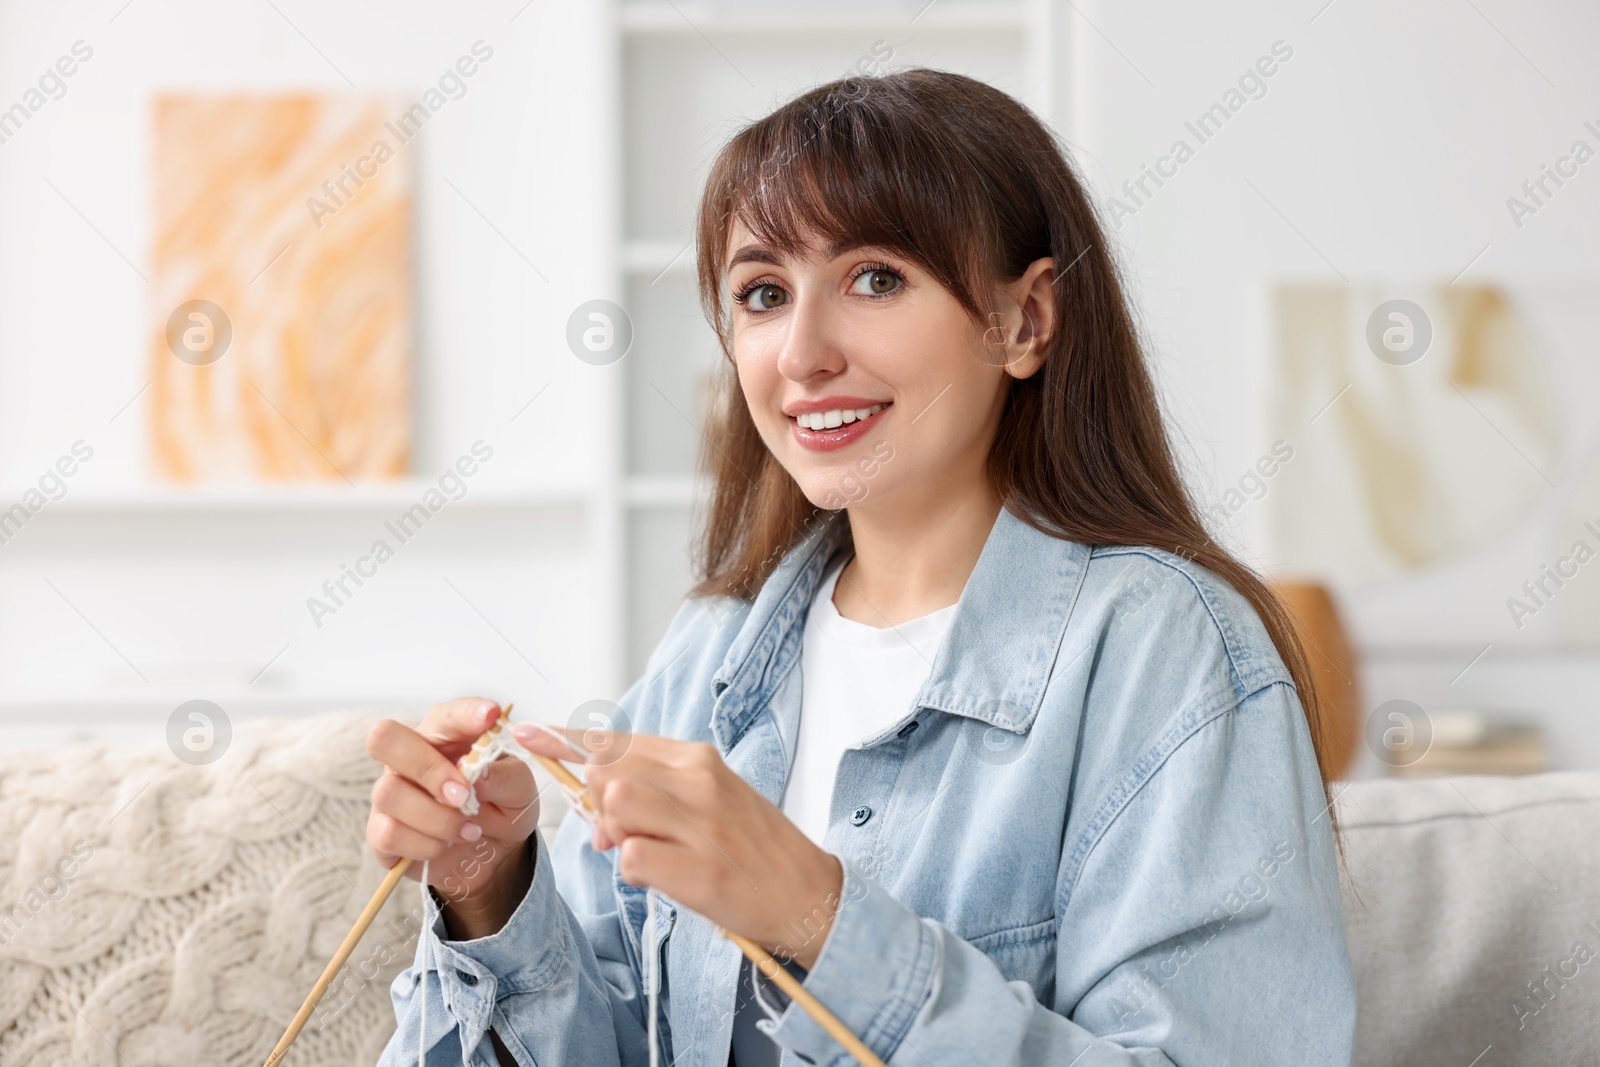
[614,0,1069,677]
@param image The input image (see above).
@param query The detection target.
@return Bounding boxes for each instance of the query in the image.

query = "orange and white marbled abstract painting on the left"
[149,94,411,482]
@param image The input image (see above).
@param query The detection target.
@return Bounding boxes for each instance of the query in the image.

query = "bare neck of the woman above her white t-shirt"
[834,474,1000,627]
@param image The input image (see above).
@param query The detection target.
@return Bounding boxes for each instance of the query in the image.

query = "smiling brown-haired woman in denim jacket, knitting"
[368,70,1355,1067]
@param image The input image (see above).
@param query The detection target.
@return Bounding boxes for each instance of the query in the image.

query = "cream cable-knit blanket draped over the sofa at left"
[0,712,421,1067]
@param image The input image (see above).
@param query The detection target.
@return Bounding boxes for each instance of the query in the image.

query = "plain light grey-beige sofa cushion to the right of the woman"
[1338,771,1600,1067]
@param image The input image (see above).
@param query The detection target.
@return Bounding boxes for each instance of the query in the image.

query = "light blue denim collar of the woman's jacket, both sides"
[710,507,1090,752]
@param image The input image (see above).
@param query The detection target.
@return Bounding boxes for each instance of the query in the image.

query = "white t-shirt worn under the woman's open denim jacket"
[782,557,955,845]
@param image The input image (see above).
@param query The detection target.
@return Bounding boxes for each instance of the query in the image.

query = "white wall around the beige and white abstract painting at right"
[1067,0,1600,769]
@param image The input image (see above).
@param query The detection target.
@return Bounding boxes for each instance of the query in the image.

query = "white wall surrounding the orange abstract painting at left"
[0,0,621,748]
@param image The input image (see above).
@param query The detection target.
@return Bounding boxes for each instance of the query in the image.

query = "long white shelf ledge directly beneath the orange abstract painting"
[23,478,592,518]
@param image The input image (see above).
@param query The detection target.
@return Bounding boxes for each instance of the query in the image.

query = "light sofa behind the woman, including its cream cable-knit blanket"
[0,712,1600,1067]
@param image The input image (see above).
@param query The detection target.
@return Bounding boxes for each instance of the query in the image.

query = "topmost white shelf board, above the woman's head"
[619,0,1029,35]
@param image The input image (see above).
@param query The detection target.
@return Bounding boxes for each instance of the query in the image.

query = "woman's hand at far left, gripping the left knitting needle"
[366,697,539,937]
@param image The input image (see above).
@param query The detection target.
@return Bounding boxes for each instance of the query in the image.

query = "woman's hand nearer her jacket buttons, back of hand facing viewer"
[515,723,845,969]
